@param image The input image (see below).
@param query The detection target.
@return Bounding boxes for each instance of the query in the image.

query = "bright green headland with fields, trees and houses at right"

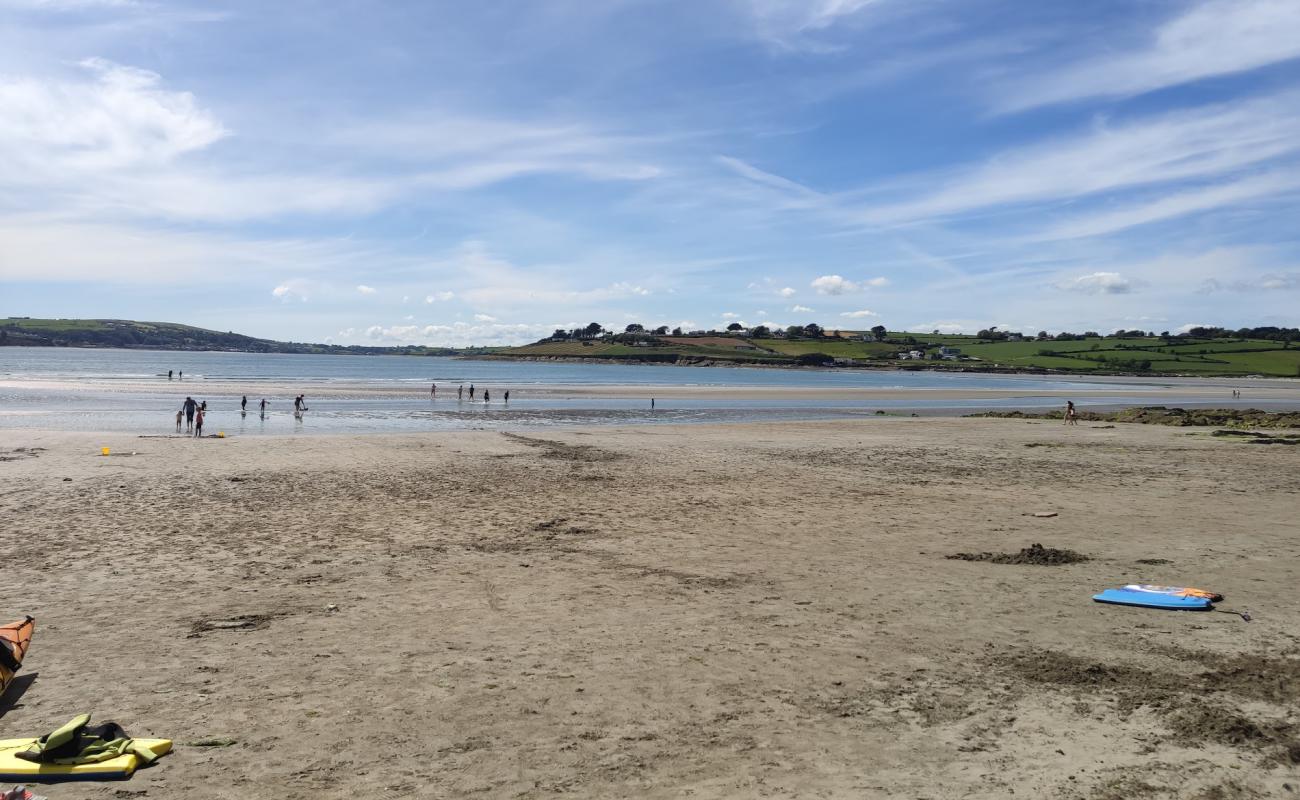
[499,332,1300,377]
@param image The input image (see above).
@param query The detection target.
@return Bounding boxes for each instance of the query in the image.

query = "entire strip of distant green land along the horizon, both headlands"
[10,317,1300,379]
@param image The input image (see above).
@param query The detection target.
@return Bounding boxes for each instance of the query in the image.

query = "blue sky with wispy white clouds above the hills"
[0,0,1300,346]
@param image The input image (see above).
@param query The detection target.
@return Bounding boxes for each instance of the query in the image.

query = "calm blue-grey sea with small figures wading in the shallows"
[0,347,1279,434]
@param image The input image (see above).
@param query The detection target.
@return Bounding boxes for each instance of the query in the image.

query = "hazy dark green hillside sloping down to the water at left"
[0,317,488,355]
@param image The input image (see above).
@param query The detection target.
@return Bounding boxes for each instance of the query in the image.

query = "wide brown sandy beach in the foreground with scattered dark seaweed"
[0,419,1300,800]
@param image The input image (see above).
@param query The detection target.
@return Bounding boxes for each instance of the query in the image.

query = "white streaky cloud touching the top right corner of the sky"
[1002,0,1300,111]
